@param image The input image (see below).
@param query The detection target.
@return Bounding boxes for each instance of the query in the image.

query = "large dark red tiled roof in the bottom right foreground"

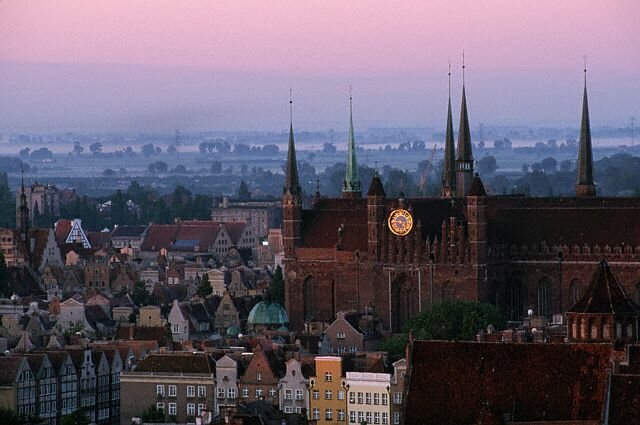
[405,341,613,425]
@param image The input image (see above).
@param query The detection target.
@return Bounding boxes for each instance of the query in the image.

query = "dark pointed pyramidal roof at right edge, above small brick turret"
[568,260,640,315]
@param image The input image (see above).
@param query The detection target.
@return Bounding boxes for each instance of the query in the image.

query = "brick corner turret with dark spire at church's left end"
[282,92,302,258]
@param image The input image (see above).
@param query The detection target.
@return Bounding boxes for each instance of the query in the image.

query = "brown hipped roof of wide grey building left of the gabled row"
[135,353,215,375]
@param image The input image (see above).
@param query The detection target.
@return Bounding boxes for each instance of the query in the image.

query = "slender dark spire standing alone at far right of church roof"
[576,56,596,197]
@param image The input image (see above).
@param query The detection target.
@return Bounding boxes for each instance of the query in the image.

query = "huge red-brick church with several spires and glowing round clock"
[283,75,640,332]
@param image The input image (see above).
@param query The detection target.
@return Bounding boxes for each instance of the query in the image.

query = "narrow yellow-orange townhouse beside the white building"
[309,356,347,425]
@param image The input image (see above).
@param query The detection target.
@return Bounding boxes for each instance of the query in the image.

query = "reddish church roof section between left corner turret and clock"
[302,198,368,251]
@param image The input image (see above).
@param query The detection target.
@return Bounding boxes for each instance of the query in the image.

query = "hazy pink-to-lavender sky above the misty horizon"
[0,0,640,132]
